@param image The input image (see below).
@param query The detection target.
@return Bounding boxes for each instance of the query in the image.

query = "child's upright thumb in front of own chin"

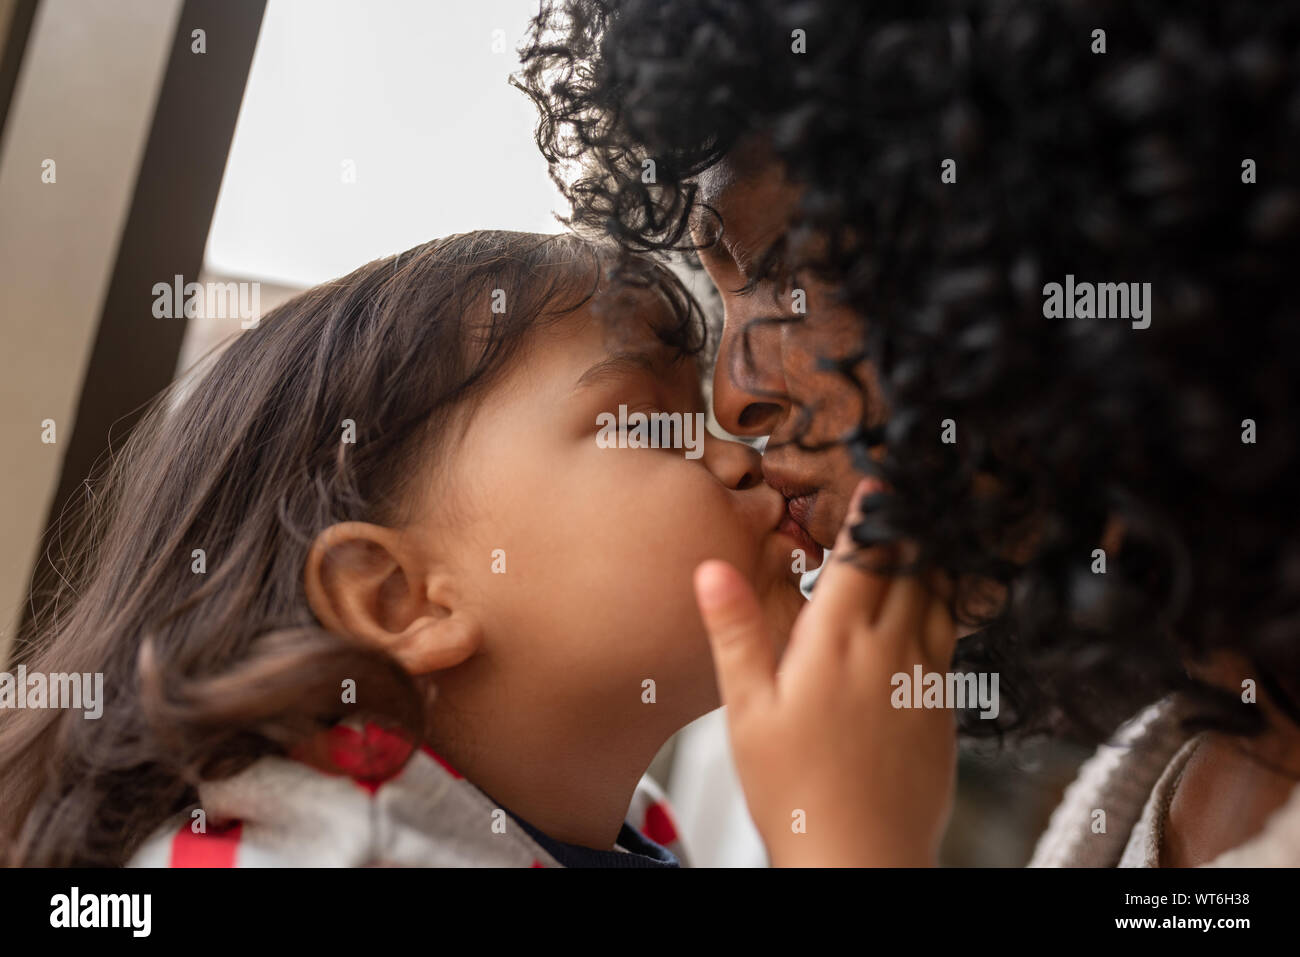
[696,562,776,720]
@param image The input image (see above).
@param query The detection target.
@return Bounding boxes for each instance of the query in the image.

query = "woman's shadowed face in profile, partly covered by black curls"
[693,147,884,547]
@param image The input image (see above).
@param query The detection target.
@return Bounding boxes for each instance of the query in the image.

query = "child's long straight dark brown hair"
[0,231,703,865]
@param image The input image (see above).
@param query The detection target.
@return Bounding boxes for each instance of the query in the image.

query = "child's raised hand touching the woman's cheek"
[696,479,957,866]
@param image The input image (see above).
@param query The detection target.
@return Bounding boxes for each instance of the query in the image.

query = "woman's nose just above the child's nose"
[714,302,790,436]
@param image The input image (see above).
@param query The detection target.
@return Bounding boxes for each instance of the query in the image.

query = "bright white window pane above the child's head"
[204,0,566,287]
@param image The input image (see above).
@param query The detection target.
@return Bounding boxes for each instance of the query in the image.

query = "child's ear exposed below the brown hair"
[303,521,482,675]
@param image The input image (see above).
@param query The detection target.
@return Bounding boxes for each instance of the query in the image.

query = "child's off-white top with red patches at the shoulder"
[129,724,689,867]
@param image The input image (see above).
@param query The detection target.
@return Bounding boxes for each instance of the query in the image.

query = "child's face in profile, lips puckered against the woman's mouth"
[413,283,820,733]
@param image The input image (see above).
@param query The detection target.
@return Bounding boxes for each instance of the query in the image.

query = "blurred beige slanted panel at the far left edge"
[0,0,181,661]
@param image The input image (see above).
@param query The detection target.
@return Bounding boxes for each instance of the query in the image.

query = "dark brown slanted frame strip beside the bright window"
[13,0,267,664]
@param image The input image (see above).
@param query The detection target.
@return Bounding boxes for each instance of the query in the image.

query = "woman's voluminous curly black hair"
[515,0,1300,740]
